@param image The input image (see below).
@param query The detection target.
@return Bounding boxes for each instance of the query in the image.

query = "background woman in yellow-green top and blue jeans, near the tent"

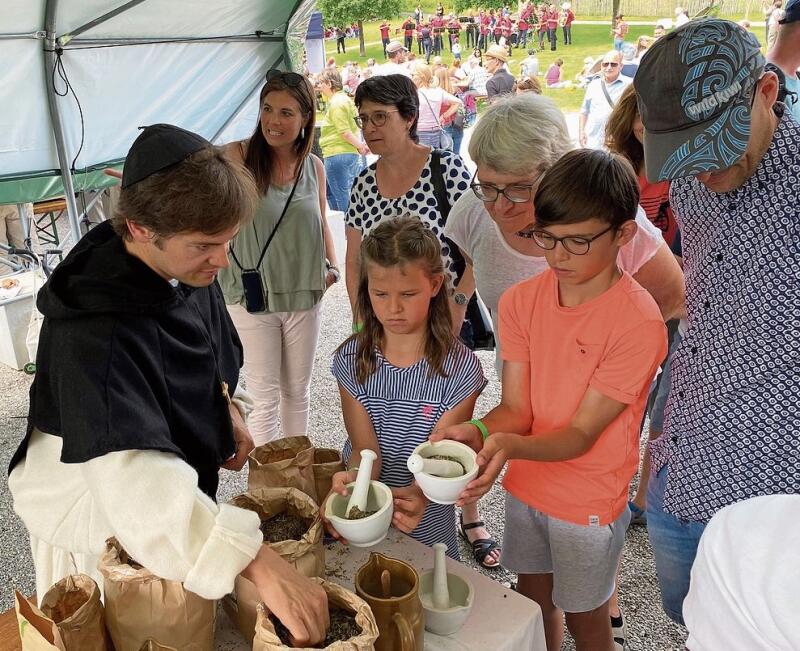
[317,68,369,212]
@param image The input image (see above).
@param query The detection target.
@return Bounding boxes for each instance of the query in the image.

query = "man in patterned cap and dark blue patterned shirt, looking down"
[634,19,800,623]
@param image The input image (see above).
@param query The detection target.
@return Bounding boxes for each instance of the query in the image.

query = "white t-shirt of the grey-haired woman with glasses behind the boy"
[444,191,667,366]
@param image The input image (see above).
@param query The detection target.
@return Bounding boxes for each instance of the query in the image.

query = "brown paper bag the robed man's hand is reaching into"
[253,579,378,651]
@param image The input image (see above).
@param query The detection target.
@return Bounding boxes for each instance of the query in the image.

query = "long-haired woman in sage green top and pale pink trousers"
[219,70,339,445]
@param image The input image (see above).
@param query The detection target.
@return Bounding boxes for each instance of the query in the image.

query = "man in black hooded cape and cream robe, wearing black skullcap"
[8,124,328,646]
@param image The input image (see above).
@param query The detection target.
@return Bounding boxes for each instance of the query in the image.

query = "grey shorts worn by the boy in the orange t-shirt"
[500,493,631,613]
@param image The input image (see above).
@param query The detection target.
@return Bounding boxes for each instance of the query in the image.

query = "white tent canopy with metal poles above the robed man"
[0,0,315,239]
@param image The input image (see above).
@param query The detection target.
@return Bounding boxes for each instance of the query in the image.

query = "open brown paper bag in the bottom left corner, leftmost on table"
[16,574,111,651]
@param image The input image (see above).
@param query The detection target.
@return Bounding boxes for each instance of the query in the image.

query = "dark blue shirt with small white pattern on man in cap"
[650,104,800,522]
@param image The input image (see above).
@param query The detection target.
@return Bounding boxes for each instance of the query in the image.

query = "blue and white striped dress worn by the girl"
[331,338,486,560]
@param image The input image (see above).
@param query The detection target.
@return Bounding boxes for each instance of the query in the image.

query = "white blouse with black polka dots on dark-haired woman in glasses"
[345,151,471,282]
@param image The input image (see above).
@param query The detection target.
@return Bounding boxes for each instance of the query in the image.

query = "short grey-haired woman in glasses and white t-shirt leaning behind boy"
[444,93,685,638]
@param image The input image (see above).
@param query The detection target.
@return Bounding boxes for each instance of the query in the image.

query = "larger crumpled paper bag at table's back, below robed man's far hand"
[247,436,317,498]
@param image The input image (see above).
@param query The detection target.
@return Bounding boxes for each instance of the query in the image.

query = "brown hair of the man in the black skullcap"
[111,146,258,239]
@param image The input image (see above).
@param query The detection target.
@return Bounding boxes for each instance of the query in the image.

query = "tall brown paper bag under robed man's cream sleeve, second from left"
[98,538,217,651]
